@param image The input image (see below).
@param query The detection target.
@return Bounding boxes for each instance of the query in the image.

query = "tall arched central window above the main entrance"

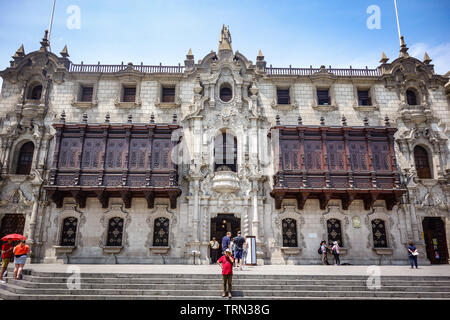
[214,132,237,172]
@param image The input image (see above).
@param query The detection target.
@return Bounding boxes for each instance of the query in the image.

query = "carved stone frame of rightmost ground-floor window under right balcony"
[366,206,396,255]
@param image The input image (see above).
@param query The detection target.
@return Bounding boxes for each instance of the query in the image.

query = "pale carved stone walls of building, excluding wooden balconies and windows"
[0,29,450,264]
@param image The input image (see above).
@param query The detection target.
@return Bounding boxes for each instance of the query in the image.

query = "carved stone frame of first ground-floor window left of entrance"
[145,205,177,254]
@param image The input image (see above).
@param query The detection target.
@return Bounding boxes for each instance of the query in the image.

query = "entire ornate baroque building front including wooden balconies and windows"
[0,27,450,264]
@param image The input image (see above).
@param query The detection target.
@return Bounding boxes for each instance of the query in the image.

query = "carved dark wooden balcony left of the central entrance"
[45,123,181,208]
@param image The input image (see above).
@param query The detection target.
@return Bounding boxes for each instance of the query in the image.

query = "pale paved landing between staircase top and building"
[20,264,450,277]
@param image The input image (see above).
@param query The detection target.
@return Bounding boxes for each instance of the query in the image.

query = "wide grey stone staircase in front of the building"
[0,270,450,300]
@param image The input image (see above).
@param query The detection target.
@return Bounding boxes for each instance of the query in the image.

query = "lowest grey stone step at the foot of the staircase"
[1,284,450,299]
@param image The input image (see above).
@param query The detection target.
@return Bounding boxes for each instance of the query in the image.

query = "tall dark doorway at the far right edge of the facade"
[422,217,448,264]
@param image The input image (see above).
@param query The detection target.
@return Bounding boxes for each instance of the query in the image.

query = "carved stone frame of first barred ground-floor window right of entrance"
[274,205,305,255]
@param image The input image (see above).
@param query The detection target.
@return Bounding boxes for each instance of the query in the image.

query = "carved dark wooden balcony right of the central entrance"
[269,125,406,210]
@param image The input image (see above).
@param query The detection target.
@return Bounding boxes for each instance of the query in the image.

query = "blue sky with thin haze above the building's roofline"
[0,0,450,90]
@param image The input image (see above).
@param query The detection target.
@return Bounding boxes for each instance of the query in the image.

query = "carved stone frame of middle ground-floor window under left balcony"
[99,203,131,254]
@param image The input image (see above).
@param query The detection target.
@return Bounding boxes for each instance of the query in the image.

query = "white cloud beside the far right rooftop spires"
[409,42,450,75]
